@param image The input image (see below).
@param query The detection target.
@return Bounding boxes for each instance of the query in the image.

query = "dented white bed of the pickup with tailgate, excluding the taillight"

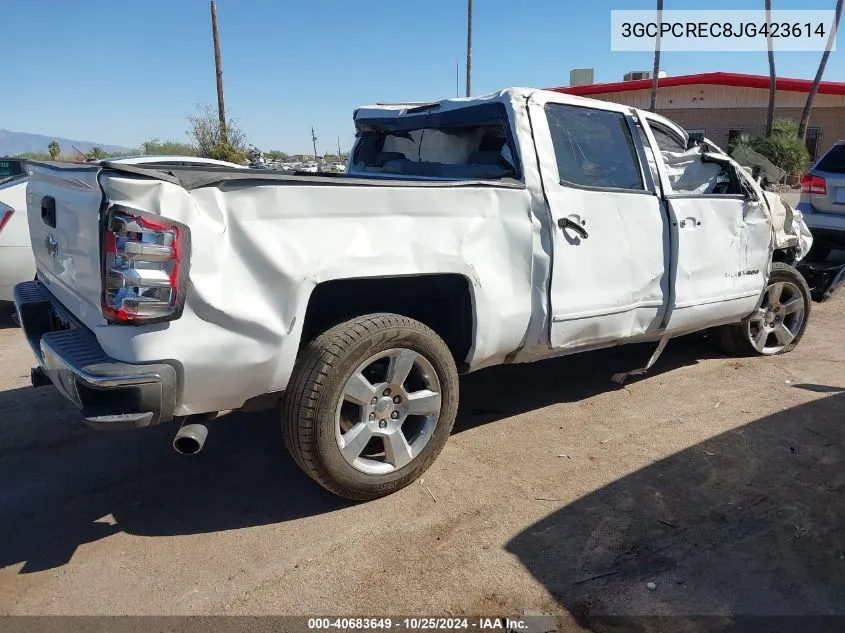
[28,161,548,415]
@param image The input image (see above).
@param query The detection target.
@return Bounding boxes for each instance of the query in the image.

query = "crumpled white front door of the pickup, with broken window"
[644,115,771,333]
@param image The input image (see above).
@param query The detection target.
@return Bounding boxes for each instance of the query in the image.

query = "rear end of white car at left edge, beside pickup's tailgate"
[0,158,35,304]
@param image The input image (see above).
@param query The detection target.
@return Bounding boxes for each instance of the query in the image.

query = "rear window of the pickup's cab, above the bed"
[352,103,520,180]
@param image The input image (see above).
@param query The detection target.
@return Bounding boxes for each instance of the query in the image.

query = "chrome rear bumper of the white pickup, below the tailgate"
[14,281,177,430]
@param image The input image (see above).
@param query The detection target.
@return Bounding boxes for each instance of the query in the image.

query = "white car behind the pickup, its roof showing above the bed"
[0,155,246,302]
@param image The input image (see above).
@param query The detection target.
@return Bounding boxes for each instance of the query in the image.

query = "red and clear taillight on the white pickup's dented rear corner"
[103,207,190,323]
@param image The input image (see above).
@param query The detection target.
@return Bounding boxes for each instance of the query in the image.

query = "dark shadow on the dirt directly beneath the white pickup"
[0,337,713,573]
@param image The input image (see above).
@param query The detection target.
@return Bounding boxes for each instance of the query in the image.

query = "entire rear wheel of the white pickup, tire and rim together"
[282,313,458,500]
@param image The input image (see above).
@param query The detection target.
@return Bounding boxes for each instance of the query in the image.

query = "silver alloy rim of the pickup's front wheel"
[746,281,804,354]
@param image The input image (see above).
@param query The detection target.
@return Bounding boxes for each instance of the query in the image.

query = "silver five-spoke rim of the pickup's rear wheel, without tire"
[335,348,441,475]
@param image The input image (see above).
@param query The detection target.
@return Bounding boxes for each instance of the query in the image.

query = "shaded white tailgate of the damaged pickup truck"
[26,163,104,328]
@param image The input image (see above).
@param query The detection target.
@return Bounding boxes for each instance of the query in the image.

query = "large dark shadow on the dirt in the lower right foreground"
[507,385,845,631]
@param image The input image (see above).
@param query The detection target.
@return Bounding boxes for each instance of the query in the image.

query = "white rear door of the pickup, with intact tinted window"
[531,100,669,349]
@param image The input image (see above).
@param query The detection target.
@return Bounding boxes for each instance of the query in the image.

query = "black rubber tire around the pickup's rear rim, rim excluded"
[282,313,458,501]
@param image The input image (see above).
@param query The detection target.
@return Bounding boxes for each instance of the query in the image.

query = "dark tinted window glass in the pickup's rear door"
[546,103,645,191]
